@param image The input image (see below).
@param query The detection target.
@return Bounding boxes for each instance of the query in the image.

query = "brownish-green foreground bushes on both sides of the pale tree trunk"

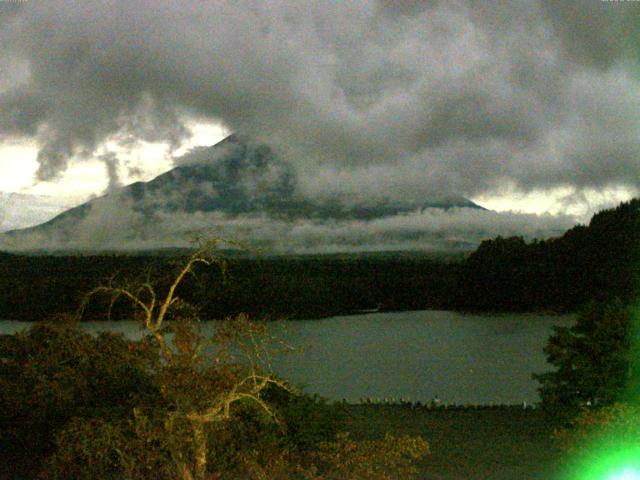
[0,323,428,480]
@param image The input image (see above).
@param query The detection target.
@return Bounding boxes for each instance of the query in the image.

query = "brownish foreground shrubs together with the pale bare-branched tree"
[0,244,428,480]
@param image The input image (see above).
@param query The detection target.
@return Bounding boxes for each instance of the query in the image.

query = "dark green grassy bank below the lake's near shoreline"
[345,405,561,480]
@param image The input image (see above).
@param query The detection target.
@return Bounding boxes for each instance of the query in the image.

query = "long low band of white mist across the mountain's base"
[4,202,574,253]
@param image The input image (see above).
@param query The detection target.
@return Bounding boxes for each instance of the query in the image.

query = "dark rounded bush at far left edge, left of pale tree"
[0,319,156,476]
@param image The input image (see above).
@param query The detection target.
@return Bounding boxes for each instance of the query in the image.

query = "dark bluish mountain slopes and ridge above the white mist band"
[5,134,484,248]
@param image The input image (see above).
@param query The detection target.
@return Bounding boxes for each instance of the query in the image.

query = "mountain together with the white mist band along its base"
[2,135,571,252]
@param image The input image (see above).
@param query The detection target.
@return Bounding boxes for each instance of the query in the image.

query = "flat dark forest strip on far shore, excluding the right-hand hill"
[0,251,458,321]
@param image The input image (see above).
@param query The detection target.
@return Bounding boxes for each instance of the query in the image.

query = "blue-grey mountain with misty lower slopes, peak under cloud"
[6,135,482,248]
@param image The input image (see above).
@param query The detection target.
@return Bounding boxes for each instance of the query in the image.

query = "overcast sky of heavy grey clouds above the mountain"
[0,0,640,227]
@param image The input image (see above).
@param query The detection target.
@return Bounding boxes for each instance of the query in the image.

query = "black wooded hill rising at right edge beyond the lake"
[454,199,640,312]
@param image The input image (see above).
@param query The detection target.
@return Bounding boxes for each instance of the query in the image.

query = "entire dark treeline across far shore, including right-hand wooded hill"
[0,199,640,320]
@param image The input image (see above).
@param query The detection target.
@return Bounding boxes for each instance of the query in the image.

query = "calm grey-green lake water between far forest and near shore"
[0,310,575,404]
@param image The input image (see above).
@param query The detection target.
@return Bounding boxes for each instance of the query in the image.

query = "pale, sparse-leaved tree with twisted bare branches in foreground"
[79,240,291,480]
